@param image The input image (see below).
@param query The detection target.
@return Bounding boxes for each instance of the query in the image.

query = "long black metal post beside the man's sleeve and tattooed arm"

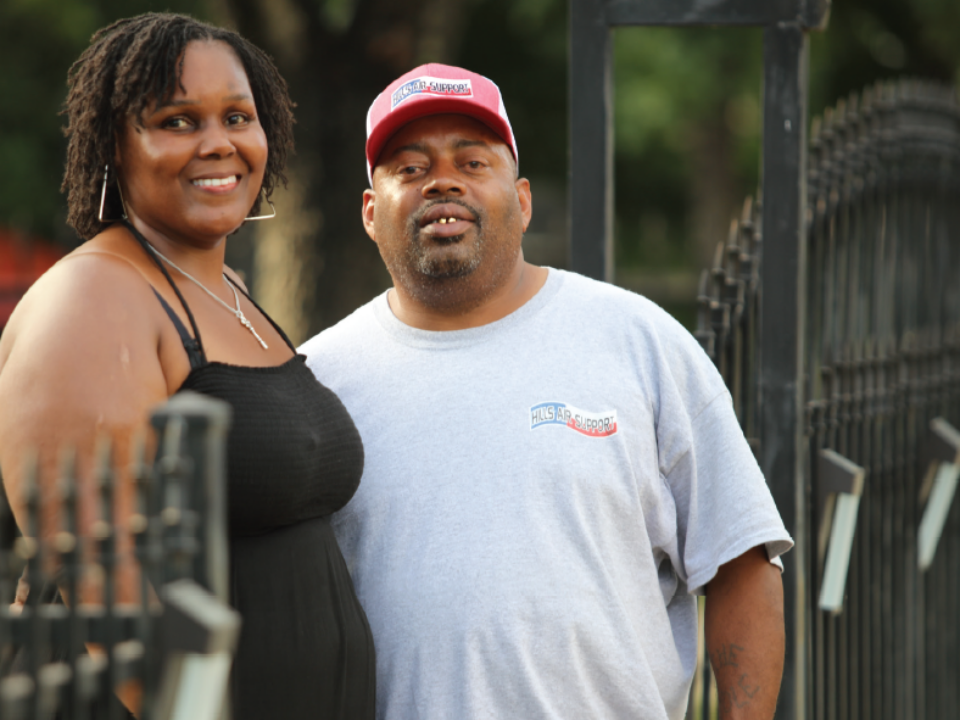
[760,23,808,720]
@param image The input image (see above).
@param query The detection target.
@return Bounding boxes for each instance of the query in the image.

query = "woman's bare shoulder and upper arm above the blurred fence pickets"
[0,228,169,532]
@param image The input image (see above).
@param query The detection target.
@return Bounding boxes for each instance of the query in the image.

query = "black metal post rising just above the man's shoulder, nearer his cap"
[569,0,613,282]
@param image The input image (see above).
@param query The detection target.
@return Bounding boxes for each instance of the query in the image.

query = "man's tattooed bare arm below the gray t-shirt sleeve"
[705,546,784,720]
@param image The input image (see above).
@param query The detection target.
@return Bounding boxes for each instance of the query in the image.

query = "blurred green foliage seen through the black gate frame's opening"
[614,28,762,267]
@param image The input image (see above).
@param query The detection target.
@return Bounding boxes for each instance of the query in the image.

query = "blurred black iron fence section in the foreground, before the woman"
[0,393,240,720]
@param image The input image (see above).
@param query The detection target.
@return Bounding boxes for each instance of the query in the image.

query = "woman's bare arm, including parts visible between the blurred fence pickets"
[0,254,167,603]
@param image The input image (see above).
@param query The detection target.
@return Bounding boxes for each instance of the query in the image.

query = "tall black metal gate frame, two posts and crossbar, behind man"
[570,0,831,719]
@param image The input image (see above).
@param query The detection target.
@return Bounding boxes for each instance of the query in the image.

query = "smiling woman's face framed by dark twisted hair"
[116,41,267,245]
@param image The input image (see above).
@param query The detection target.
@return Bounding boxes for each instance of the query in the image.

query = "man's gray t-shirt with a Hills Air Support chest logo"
[301,270,792,720]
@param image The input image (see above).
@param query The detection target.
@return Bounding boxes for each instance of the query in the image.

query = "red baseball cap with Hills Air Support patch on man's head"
[367,63,520,185]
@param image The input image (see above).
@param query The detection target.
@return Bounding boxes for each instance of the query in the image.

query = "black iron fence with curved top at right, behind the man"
[691,81,960,720]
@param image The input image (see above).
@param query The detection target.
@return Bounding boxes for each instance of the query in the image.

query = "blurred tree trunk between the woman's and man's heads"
[222,0,467,342]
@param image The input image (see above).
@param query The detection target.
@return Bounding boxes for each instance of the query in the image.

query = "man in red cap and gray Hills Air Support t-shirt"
[303,65,791,720]
